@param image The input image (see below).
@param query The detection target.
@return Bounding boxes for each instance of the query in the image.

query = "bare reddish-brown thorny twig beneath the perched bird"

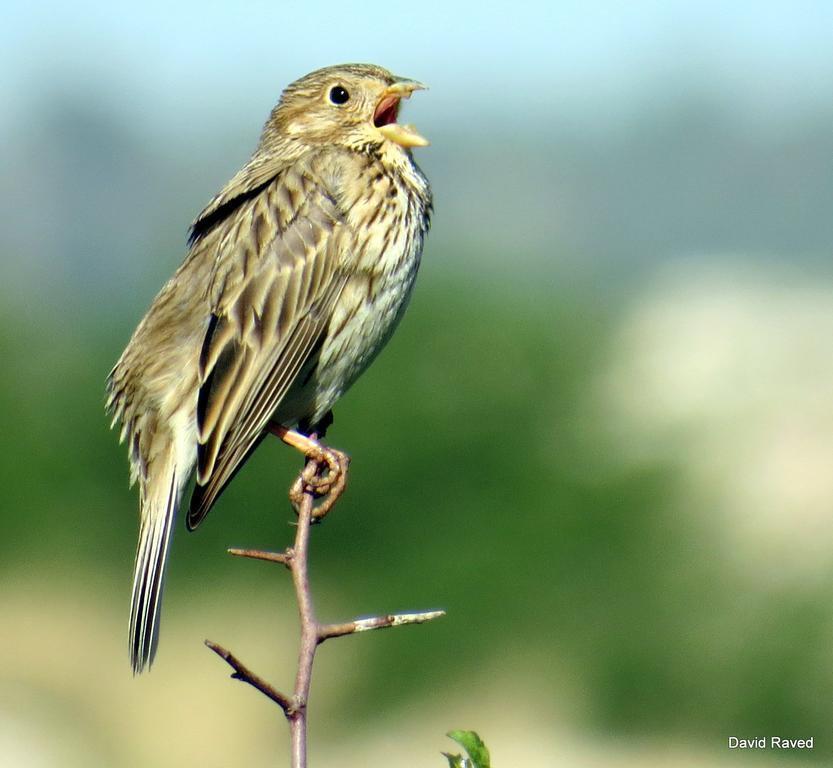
[205,452,445,768]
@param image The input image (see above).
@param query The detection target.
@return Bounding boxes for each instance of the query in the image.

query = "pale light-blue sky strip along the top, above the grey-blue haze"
[0,0,833,134]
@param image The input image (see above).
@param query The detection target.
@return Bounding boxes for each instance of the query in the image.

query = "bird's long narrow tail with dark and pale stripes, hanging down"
[129,461,182,675]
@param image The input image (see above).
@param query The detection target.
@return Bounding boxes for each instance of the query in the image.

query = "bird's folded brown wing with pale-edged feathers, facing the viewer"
[187,163,346,529]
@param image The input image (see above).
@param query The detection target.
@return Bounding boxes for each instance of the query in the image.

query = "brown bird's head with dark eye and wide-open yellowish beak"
[263,64,428,156]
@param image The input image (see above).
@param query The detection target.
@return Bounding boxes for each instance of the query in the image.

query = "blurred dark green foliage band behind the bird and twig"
[0,249,833,755]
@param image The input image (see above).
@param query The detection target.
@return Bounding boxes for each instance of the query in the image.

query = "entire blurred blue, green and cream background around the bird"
[0,0,833,768]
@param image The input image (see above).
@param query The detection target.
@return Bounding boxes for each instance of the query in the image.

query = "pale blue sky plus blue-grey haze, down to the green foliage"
[0,0,833,301]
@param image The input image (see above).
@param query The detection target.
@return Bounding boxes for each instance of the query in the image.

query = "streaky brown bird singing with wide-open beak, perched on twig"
[106,64,433,675]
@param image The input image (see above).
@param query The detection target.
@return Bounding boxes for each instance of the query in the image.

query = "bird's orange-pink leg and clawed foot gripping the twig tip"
[269,423,350,520]
